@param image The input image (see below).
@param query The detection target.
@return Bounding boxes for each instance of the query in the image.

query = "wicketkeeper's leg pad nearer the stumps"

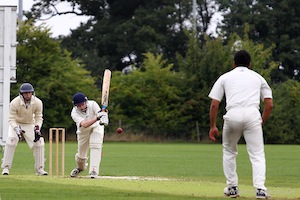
[33,137,45,170]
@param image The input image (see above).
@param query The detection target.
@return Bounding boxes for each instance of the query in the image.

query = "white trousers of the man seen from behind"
[222,107,267,190]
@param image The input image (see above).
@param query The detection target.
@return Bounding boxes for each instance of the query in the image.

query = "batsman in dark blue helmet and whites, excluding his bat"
[70,92,108,178]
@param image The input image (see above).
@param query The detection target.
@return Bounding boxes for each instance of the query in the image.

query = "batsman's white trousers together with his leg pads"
[76,124,104,174]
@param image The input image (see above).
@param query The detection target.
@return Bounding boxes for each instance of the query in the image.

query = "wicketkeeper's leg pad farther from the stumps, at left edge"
[1,137,19,169]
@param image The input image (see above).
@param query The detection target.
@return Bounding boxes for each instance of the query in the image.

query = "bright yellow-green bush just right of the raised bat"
[110,53,189,138]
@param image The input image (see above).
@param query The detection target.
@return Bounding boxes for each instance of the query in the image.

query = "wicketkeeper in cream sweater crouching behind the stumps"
[1,83,48,176]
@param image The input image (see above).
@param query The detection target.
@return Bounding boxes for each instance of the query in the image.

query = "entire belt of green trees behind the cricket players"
[19,0,300,143]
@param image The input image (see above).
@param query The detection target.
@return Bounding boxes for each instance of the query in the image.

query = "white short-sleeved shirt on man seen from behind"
[208,67,272,111]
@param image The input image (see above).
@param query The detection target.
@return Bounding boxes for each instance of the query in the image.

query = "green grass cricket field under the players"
[0,142,300,200]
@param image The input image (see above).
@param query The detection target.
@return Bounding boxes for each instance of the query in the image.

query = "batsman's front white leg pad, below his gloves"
[89,132,103,174]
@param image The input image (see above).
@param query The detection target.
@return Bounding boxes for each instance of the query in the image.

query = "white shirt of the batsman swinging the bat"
[71,100,101,131]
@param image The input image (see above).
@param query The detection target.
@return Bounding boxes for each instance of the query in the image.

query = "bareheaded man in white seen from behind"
[208,50,273,199]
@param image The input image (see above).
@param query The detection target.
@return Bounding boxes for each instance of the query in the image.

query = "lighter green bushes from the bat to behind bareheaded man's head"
[106,28,276,139]
